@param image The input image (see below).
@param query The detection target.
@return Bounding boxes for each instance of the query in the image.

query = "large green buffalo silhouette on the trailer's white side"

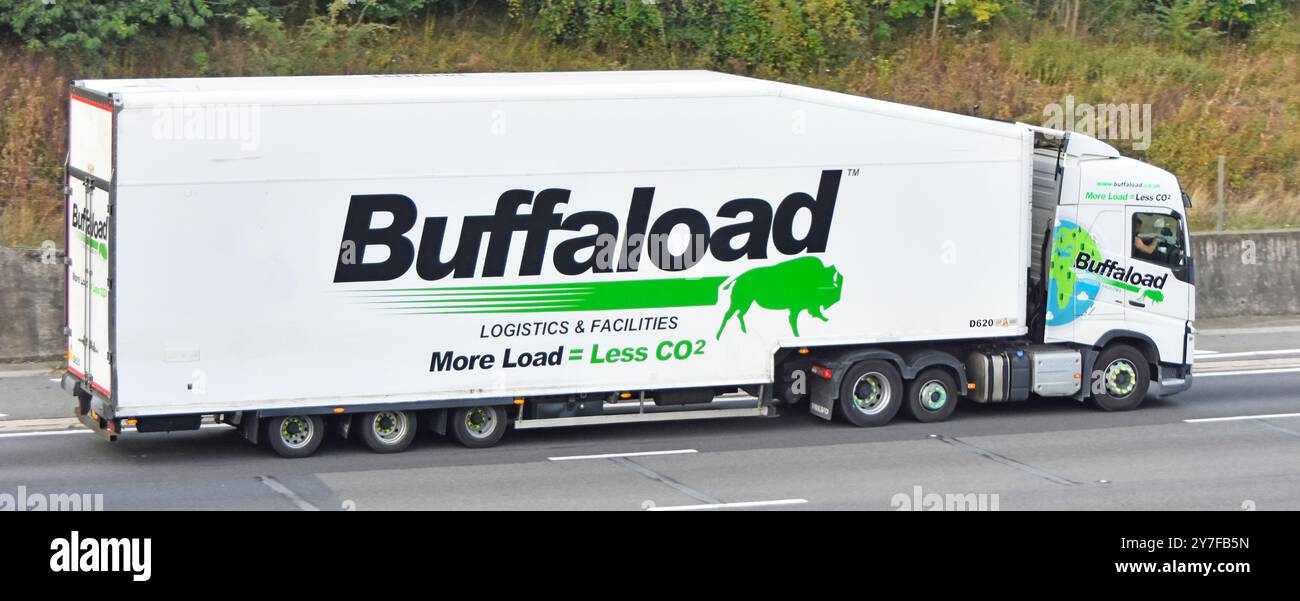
[715,256,844,340]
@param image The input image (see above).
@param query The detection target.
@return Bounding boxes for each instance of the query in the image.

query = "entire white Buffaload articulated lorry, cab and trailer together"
[64,72,1196,457]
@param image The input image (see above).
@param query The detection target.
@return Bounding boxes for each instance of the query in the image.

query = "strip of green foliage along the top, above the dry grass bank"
[0,0,1297,53]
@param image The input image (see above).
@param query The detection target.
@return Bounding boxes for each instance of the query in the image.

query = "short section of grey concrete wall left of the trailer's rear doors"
[0,247,65,362]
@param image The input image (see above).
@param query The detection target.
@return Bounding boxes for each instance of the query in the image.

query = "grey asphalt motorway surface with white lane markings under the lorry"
[0,323,1300,510]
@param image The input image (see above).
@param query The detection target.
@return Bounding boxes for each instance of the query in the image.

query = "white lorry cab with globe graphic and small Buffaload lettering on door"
[1035,131,1196,408]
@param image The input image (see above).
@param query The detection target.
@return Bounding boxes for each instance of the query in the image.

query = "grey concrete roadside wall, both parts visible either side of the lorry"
[0,229,1300,362]
